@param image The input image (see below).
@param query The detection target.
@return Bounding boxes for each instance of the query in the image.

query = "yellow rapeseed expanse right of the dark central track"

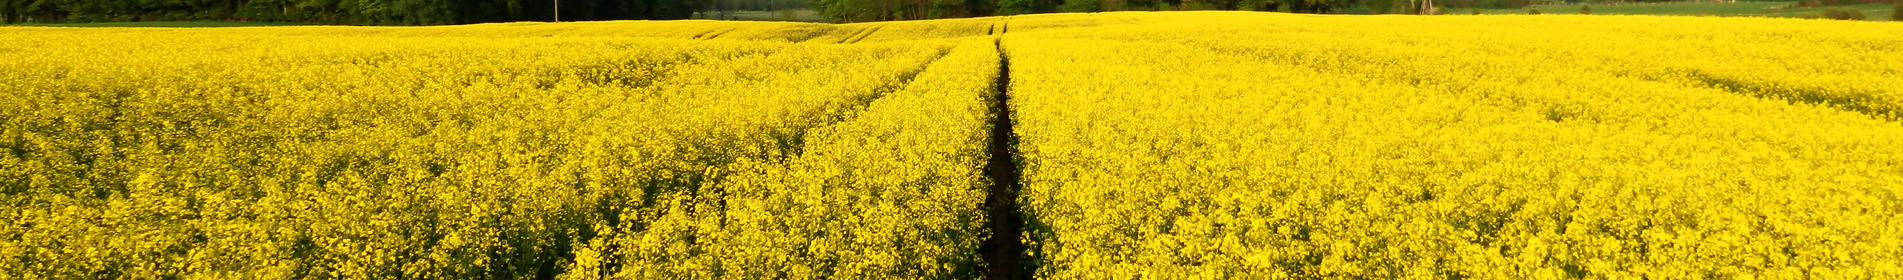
[1003,13,1903,278]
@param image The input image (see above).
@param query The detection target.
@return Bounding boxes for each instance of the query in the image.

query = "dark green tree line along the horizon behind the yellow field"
[0,0,1377,25]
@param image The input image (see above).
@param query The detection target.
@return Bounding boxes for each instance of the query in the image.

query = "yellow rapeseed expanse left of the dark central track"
[0,21,999,278]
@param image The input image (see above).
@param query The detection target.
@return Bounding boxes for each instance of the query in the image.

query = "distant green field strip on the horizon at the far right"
[1476,2,1892,21]
